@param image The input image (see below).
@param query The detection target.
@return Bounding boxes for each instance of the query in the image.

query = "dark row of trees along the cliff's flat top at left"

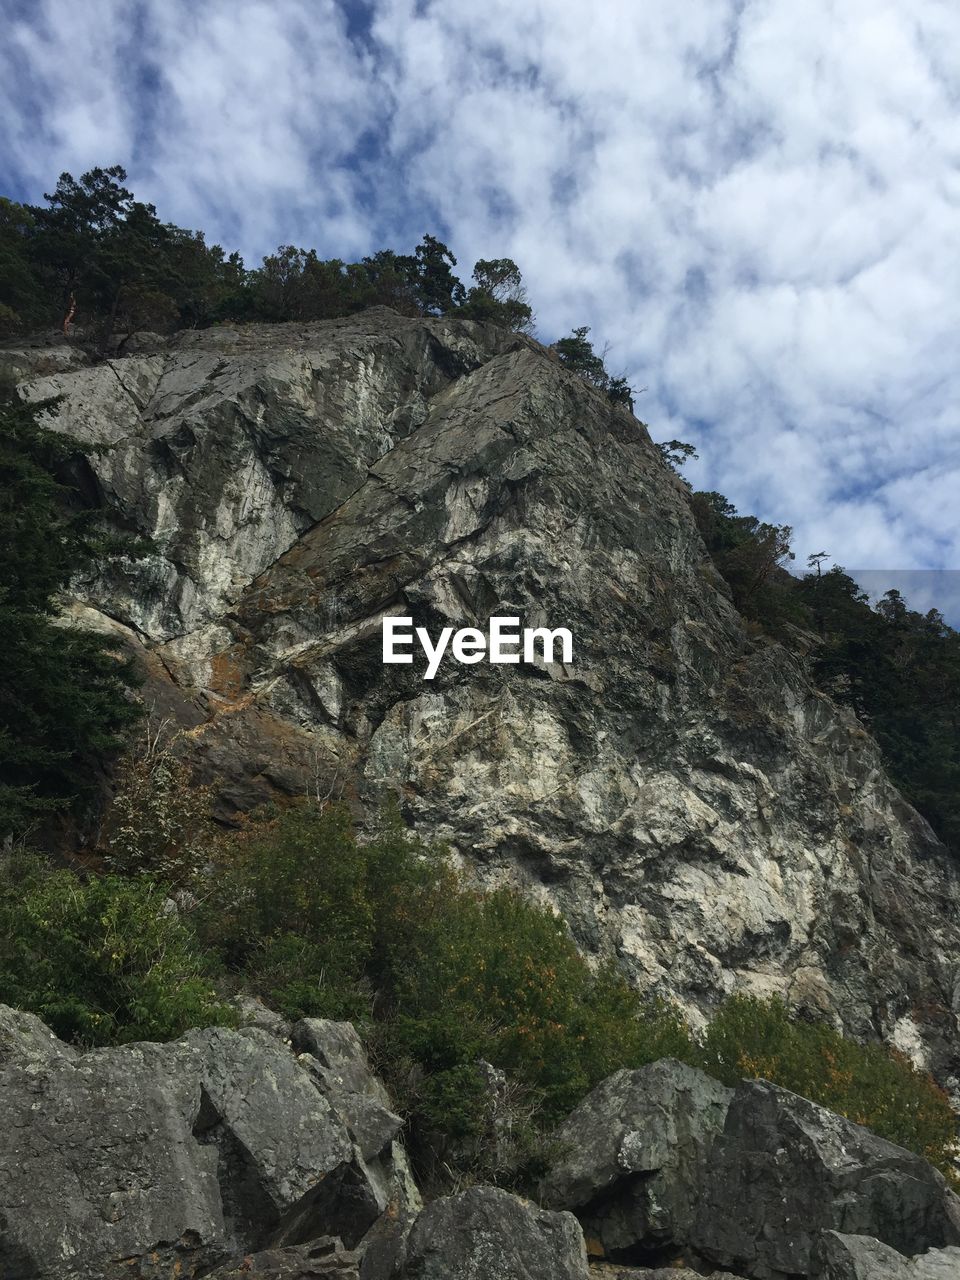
[0,166,542,349]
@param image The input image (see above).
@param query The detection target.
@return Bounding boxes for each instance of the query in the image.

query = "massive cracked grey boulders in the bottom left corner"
[0,1010,403,1280]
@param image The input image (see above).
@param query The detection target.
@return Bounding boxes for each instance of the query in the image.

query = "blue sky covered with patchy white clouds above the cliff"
[0,0,960,588]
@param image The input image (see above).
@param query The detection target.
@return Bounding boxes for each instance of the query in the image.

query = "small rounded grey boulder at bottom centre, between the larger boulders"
[397,1187,589,1280]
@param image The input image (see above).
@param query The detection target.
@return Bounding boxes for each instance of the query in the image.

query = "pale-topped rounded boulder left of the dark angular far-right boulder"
[541,1059,733,1256]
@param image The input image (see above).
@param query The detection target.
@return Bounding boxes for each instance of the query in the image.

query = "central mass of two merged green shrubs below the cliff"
[204,805,690,1128]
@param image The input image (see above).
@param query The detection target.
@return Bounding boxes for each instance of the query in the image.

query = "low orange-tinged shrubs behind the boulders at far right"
[701,995,956,1172]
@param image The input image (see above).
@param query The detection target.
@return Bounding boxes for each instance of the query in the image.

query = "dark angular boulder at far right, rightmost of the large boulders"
[690,1080,960,1280]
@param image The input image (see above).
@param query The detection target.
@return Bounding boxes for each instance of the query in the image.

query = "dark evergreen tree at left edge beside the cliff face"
[0,401,138,837]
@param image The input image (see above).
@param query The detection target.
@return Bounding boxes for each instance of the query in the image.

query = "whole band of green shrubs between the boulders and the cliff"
[0,788,955,1183]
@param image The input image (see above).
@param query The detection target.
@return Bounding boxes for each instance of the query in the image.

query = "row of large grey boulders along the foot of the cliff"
[0,1006,960,1280]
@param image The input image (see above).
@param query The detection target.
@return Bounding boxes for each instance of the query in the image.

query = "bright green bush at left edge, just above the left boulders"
[0,858,232,1044]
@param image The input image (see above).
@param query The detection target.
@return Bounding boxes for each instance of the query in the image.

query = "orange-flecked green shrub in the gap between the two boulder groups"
[379,874,691,1120]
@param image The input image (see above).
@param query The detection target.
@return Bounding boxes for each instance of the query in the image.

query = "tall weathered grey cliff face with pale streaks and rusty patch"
[14,310,960,1082]
